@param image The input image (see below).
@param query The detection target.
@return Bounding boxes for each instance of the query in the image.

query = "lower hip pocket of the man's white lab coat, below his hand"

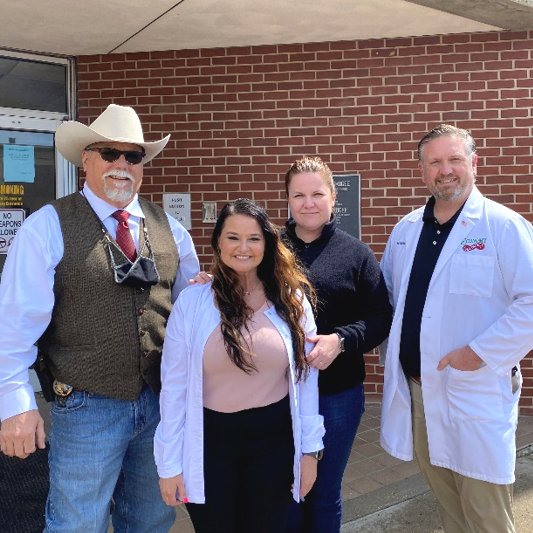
[446,366,504,420]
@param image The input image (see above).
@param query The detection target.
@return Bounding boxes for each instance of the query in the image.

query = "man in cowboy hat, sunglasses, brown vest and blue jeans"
[0,105,199,533]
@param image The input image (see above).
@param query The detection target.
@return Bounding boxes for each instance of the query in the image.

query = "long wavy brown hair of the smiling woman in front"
[211,198,316,380]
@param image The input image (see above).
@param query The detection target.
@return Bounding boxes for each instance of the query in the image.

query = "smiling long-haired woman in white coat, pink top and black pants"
[155,199,324,533]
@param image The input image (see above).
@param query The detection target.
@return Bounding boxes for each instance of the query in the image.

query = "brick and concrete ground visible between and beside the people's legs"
[170,396,533,533]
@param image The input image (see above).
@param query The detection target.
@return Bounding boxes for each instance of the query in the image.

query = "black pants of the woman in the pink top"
[187,396,294,533]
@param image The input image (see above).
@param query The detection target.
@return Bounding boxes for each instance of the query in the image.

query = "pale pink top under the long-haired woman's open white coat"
[203,302,289,413]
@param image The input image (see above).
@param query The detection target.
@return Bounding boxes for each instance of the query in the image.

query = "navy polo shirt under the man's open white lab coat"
[400,197,464,378]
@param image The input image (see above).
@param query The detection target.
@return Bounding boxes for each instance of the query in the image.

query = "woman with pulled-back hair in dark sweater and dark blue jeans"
[283,157,392,533]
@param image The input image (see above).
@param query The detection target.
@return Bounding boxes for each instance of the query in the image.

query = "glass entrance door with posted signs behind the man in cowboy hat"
[0,49,77,391]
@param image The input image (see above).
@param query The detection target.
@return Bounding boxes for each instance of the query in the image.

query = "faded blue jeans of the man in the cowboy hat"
[45,387,175,533]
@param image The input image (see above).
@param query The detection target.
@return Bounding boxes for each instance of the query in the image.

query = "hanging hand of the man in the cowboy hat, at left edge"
[0,409,45,459]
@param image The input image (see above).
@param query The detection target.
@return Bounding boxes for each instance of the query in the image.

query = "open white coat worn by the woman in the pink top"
[154,283,324,503]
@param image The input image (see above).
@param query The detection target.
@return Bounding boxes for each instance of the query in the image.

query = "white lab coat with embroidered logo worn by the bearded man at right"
[381,188,533,484]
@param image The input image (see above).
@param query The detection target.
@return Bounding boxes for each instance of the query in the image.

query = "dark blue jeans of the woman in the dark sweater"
[287,384,365,533]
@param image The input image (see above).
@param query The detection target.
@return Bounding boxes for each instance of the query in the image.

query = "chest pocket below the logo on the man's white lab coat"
[450,252,495,298]
